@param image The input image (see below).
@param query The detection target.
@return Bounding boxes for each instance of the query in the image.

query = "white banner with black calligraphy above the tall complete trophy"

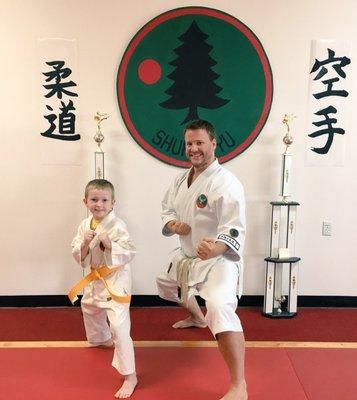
[306,40,352,166]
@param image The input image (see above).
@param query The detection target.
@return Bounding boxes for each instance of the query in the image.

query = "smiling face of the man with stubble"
[185,129,217,171]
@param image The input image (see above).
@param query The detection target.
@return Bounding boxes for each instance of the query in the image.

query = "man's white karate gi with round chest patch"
[157,160,245,335]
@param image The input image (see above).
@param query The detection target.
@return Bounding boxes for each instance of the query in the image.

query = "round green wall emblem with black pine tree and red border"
[117,7,273,167]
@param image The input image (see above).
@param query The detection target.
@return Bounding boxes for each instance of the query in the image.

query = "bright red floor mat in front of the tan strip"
[0,347,357,400]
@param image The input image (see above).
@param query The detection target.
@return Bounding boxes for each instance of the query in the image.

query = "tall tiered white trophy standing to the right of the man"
[263,115,300,318]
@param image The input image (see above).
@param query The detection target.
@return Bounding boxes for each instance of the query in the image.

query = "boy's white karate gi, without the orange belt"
[72,211,136,375]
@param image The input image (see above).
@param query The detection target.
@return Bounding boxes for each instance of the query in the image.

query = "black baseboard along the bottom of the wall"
[0,295,357,308]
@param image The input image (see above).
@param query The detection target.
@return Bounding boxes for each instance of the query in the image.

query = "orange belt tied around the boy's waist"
[67,266,131,304]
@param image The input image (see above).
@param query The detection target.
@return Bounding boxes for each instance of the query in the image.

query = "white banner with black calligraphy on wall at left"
[38,38,81,165]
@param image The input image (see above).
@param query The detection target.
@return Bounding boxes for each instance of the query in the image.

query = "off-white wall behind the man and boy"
[0,0,357,296]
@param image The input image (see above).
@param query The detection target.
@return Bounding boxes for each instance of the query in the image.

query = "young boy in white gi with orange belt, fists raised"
[72,179,137,398]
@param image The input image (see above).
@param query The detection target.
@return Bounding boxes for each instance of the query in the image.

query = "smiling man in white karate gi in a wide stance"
[157,120,248,400]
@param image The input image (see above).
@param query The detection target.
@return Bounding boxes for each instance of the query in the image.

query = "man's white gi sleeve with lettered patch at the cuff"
[213,180,246,261]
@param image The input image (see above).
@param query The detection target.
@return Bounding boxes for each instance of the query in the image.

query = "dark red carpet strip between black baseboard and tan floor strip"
[0,307,357,342]
